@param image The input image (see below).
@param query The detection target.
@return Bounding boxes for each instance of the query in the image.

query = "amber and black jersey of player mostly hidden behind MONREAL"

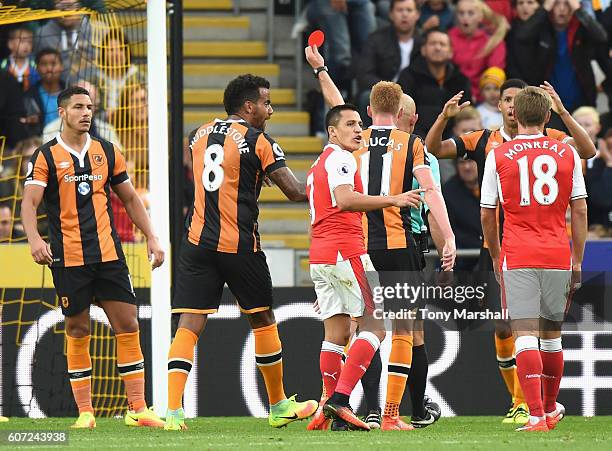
[451,127,571,186]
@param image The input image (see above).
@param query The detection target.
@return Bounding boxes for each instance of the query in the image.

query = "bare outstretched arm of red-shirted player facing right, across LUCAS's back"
[334,185,423,211]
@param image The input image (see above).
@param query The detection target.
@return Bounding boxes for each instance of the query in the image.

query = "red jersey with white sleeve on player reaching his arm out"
[306,144,366,264]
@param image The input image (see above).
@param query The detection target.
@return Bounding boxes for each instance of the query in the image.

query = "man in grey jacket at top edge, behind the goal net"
[35,0,93,80]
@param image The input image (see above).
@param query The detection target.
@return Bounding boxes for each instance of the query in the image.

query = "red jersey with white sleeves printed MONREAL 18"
[480,134,587,269]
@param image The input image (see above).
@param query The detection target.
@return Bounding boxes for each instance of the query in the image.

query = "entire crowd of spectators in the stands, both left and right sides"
[0,0,612,248]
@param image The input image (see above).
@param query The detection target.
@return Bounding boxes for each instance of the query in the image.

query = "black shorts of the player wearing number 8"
[172,239,272,314]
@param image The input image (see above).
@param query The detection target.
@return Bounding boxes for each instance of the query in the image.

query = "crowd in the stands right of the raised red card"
[305,0,612,244]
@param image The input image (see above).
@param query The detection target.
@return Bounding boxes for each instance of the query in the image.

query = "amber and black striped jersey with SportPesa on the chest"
[25,134,129,267]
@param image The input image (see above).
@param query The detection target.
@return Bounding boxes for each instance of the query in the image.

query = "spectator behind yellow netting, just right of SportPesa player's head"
[98,29,140,114]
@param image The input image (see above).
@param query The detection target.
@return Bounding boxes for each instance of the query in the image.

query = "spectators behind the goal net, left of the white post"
[0,0,148,243]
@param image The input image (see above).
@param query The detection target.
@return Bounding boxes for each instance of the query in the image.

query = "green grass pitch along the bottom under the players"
[0,417,612,451]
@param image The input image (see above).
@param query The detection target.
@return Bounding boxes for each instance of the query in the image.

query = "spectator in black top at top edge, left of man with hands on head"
[506,0,544,86]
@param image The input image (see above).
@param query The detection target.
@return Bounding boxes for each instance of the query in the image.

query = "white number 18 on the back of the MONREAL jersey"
[517,155,559,207]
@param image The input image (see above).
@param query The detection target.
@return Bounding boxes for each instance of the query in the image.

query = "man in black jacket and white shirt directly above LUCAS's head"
[357,0,420,125]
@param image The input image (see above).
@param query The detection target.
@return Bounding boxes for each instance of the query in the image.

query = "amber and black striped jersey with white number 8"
[187,119,286,253]
